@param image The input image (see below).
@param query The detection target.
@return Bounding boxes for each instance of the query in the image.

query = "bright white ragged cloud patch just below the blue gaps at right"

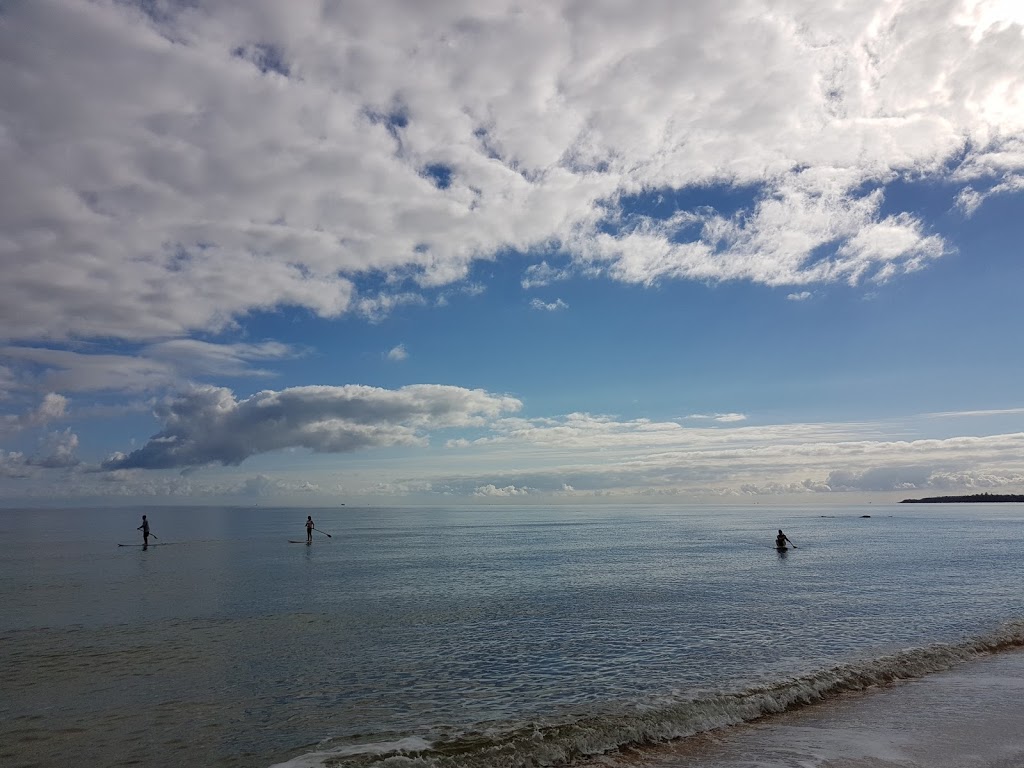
[575,175,945,286]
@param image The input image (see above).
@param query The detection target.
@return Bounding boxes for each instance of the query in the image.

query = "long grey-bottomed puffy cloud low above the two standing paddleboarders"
[103,384,520,470]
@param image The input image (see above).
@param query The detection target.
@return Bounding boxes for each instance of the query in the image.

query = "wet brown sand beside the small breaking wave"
[615,650,1024,768]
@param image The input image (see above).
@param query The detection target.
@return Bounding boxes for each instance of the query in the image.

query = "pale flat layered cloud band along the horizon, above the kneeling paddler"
[419,414,1024,497]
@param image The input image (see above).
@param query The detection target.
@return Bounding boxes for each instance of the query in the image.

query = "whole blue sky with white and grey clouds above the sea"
[0,0,1024,507]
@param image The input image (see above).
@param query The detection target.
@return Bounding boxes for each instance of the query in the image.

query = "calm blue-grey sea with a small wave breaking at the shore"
[0,505,1024,768]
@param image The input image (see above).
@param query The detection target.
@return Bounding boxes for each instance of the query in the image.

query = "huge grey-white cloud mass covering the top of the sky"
[0,0,1024,340]
